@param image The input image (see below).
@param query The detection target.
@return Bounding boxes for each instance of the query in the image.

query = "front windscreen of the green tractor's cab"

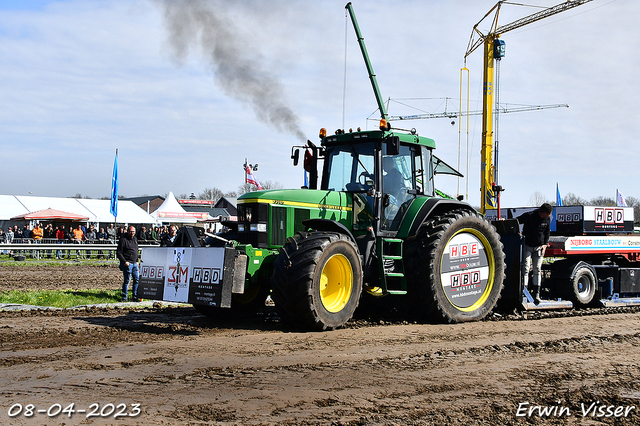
[322,143,375,192]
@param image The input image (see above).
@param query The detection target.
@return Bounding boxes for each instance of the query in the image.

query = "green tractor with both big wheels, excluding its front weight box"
[237,122,504,330]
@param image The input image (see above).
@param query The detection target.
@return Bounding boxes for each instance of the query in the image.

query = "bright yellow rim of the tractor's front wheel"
[320,254,353,313]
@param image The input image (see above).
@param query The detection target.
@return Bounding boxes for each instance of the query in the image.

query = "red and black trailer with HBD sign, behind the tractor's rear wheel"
[488,206,640,310]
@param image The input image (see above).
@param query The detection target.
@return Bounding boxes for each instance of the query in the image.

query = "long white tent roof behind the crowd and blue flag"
[0,195,156,224]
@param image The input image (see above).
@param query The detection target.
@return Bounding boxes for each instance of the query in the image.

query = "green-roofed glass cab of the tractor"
[320,123,435,235]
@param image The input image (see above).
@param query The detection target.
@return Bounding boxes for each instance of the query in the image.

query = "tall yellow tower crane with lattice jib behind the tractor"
[463,0,592,213]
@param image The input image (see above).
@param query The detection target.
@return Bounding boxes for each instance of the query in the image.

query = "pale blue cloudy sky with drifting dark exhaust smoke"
[0,0,640,207]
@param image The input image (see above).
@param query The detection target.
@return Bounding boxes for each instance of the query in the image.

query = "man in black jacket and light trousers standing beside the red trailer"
[517,203,553,304]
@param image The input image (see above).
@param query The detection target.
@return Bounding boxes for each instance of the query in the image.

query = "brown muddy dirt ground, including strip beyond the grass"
[0,265,640,425]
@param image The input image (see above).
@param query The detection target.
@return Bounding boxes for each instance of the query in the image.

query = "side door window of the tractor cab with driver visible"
[381,146,416,231]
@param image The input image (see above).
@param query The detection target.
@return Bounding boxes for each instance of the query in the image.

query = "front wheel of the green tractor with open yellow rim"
[271,231,362,330]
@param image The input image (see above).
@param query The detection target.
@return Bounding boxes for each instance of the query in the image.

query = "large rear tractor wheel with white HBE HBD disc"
[407,210,505,323]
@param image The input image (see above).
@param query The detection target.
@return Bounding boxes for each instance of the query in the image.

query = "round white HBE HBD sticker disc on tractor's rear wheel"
[440,232,490,310]
